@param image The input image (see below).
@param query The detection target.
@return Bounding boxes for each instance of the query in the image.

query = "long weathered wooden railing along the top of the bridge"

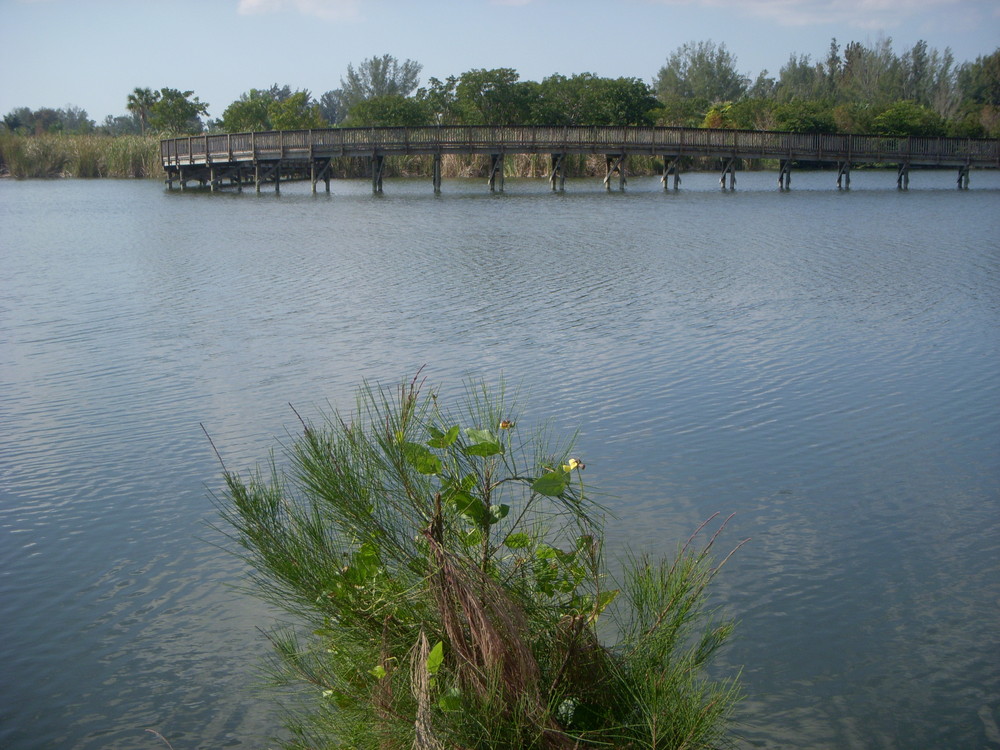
[160,125,1000,167]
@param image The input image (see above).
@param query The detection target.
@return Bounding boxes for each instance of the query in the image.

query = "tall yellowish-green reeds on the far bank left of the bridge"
[0,133,163,179]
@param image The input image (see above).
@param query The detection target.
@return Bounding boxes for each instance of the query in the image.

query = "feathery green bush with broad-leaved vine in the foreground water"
[218,379,738,749]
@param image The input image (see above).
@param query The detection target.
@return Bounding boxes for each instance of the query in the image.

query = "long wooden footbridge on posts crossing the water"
[160,126,1000,193]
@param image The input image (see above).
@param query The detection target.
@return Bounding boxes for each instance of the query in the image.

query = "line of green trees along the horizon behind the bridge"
[2,38,1000,137]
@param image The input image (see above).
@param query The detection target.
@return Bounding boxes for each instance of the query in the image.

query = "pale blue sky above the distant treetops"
[0,0,1000,123]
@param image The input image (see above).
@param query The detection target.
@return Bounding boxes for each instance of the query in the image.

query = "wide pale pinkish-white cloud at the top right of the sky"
[653,0,976,29]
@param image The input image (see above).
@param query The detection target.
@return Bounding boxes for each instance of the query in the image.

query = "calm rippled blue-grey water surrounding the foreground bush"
[0,171,1000,750]
